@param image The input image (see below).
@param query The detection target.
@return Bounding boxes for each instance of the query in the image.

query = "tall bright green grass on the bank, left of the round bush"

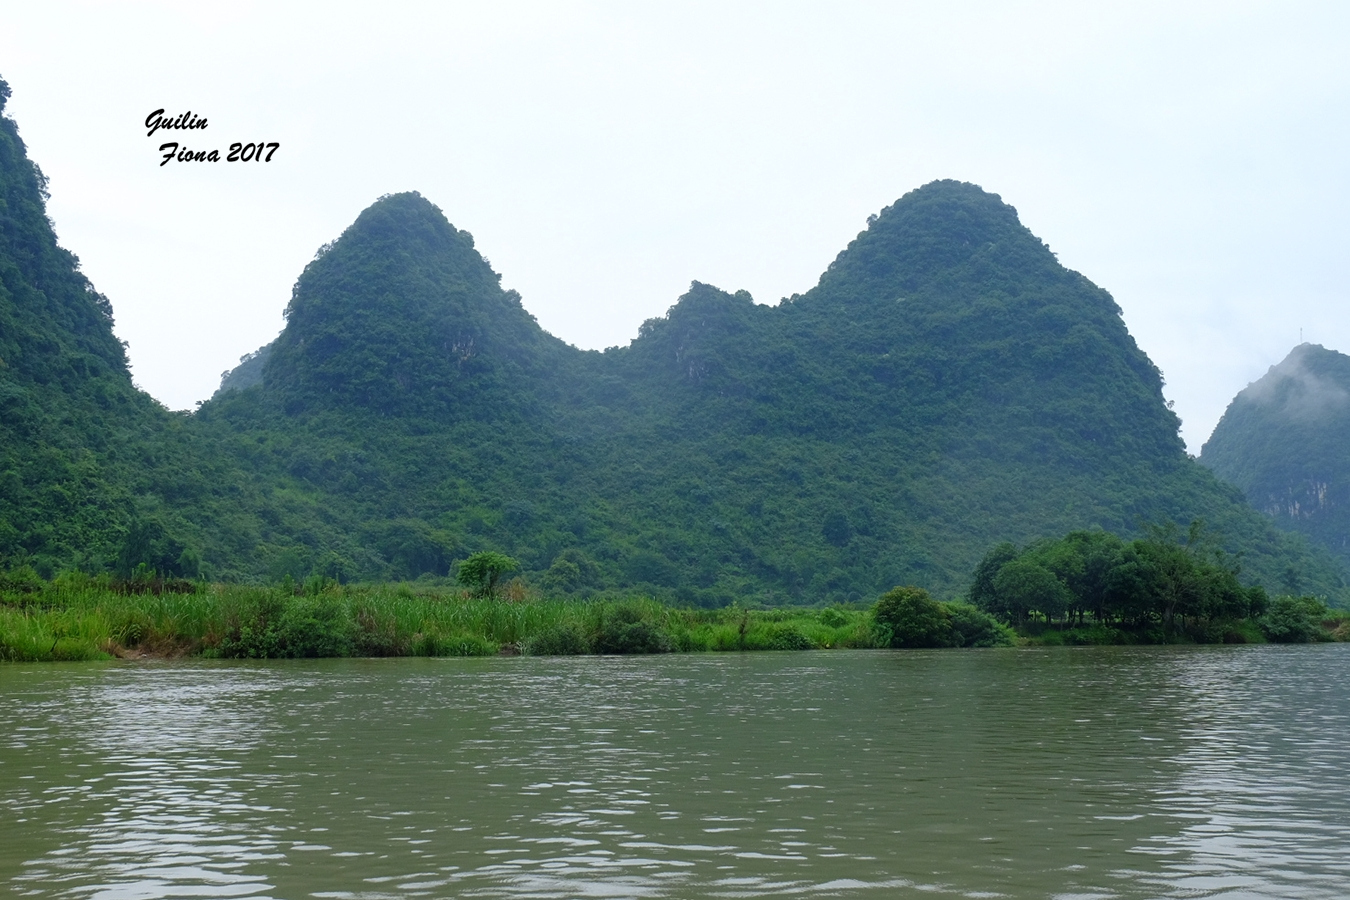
[0,575,876,661]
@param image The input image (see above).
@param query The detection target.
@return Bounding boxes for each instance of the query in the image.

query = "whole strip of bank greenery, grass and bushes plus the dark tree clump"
[0,542,1350,661]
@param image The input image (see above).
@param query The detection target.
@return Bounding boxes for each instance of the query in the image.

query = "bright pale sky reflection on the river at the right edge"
[1123,646,1350,899]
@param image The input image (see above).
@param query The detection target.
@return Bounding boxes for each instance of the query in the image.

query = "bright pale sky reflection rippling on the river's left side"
[7,667,284,900]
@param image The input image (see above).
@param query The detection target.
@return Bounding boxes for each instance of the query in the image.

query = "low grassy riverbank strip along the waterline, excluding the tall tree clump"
[0,573,1350,663]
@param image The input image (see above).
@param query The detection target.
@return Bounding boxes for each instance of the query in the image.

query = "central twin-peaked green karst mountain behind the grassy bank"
[205,181,1341,603]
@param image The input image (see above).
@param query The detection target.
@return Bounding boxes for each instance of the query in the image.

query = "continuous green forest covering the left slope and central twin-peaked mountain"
[0,73,1343,607]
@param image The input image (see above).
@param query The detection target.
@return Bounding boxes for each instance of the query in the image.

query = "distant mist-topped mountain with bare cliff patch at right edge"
[1200,344,1350,577]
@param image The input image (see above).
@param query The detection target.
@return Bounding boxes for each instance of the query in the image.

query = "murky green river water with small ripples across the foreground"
[0,645,1350,900]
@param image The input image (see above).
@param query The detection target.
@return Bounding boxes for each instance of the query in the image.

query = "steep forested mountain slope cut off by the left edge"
[0,81,325,578]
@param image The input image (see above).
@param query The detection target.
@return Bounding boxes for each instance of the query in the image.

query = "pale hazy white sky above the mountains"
[0,0,1350,452]
